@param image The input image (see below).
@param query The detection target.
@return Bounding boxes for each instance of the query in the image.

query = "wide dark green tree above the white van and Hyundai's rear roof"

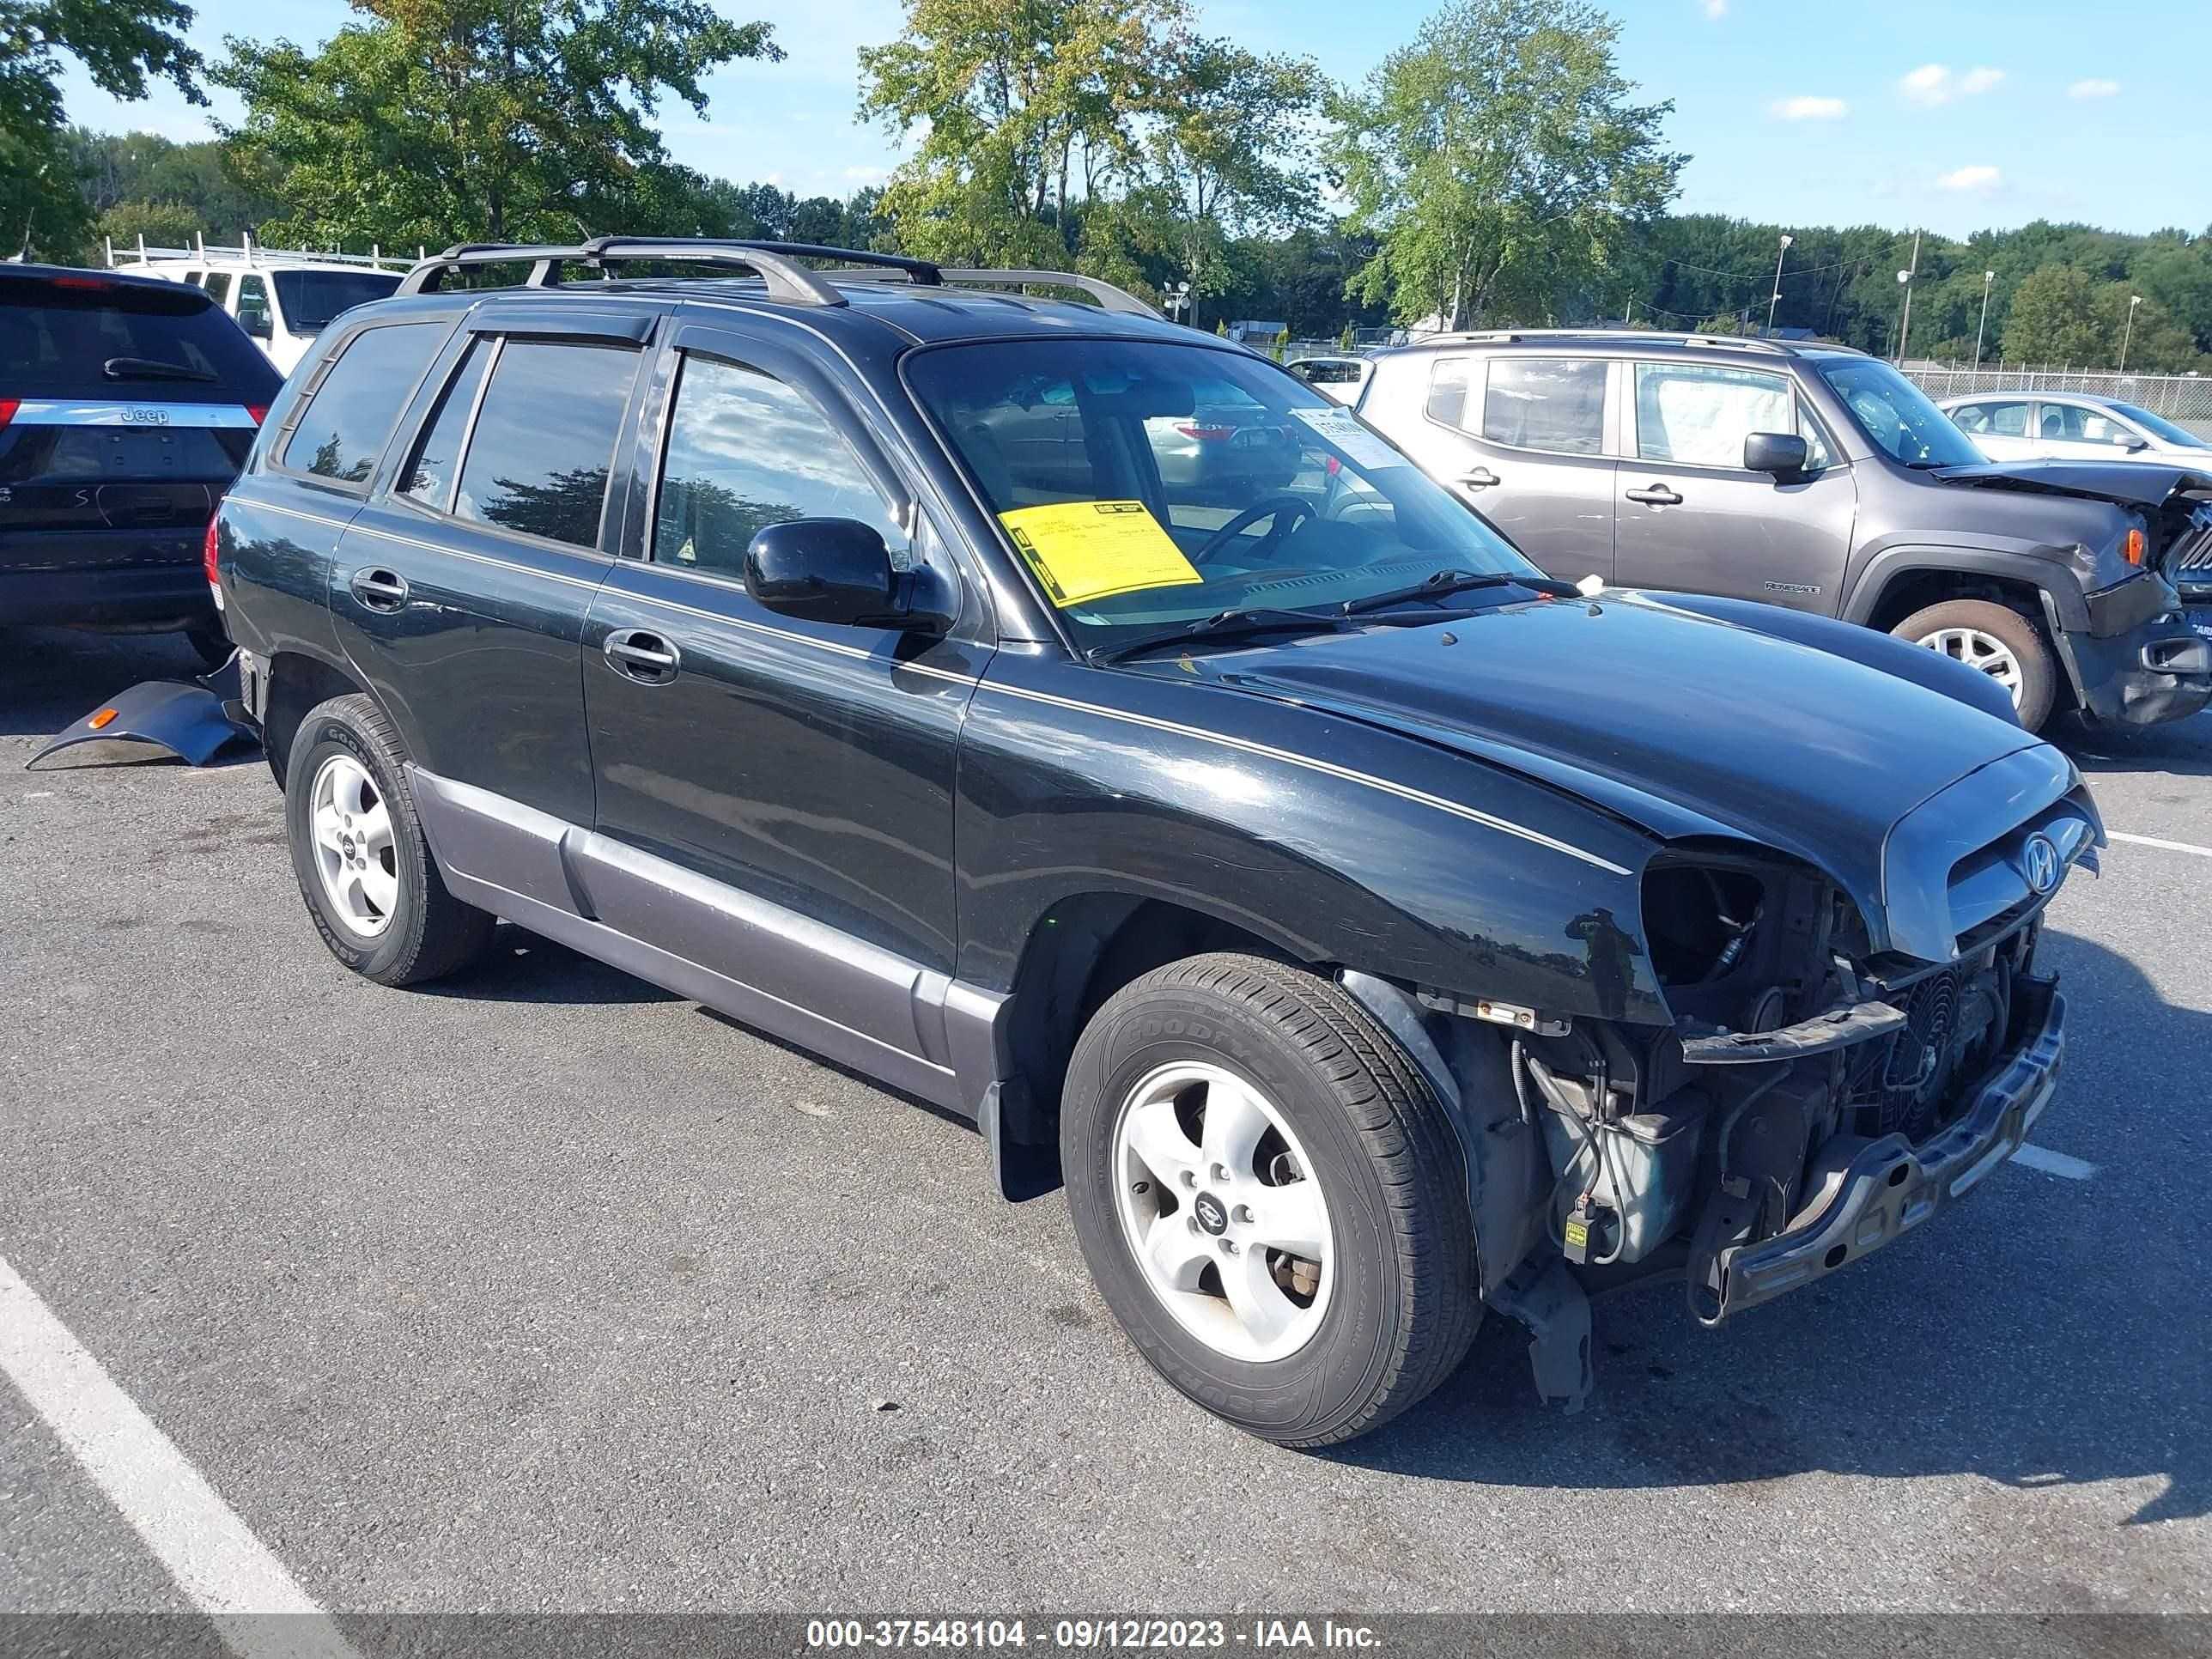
[212,0,783,248]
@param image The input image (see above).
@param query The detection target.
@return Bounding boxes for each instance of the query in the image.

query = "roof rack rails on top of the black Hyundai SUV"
[398,237,1159,319]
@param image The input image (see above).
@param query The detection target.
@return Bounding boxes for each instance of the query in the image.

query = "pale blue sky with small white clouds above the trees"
[64,0,2212,237]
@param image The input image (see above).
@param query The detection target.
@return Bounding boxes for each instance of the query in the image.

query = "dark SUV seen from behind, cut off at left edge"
[0,265,283,665]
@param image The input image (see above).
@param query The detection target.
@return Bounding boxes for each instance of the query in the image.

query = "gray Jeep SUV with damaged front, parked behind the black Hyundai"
[1358,330,2212,730]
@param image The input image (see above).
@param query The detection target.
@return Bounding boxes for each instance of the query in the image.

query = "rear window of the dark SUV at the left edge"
[0,274,283,404]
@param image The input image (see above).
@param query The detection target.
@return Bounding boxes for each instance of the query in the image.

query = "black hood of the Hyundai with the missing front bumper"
[1128,592,2042,927]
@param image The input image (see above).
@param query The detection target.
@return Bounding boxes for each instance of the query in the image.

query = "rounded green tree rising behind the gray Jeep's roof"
[1329,0,1687,327]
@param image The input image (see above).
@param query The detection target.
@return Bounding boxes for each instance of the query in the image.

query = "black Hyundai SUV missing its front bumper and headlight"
[216,239,2101,1444]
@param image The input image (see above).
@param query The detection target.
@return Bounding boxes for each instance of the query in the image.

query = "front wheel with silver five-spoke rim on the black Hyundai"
[1060,953,1482,1447]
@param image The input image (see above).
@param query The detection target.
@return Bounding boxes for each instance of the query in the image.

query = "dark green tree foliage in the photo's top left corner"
[0,0,206,258]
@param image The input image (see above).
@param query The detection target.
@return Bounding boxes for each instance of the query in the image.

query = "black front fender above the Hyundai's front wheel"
[956,650,1668,1024]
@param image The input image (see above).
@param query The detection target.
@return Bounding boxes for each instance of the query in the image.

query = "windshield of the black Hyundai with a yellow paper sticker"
[907,341,1544,648]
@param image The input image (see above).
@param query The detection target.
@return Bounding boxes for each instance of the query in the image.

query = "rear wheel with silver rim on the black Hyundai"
[283,692,493,984]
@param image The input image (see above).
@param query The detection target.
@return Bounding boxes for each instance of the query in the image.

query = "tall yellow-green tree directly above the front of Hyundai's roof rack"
[860,0,1186,265]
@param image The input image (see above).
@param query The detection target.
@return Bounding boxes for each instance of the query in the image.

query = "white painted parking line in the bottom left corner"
[0,1256,354,1659]
